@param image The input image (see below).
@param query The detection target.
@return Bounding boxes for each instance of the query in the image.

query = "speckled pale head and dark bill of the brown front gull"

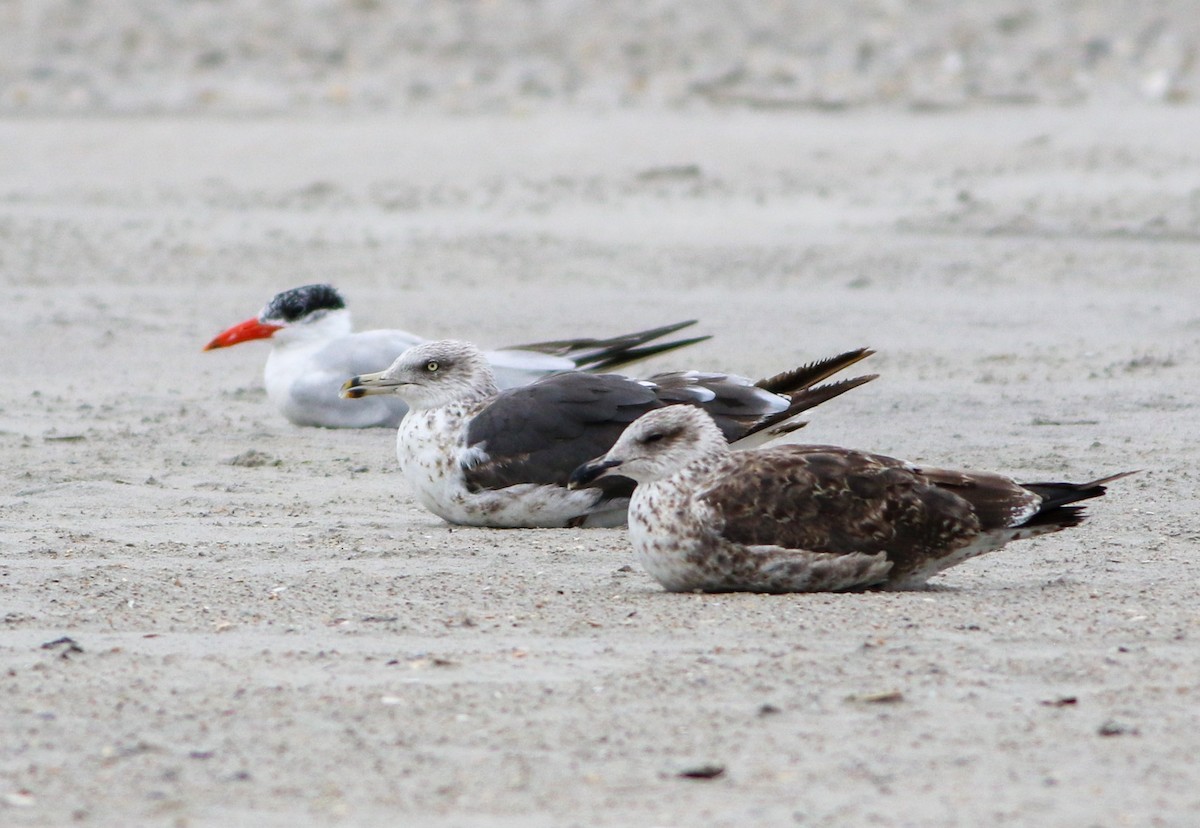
[570,406,728,488]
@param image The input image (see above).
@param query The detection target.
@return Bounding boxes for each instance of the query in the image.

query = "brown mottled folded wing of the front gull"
[698,445,979,572]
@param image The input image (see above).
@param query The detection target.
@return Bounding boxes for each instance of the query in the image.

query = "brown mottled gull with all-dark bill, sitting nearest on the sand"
[570,406,1133,593]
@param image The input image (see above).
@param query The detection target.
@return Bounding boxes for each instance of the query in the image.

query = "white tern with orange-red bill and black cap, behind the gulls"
[204,284,709,428]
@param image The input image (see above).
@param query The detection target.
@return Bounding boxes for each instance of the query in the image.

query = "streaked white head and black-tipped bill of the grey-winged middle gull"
[342,340,497,410]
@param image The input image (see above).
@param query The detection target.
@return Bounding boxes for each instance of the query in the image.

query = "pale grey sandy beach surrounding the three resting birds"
[0,0,1200,828]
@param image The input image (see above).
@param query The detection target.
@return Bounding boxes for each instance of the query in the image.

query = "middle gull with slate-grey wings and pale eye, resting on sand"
[342,341,874,528]
